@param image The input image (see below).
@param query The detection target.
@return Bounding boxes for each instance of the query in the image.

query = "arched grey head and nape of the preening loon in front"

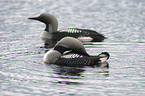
[55,37,89,56]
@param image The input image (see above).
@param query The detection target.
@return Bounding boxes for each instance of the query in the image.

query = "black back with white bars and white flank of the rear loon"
[52,28,105,42]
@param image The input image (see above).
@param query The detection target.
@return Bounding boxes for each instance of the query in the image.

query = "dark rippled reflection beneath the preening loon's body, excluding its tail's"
[45,64,85,85]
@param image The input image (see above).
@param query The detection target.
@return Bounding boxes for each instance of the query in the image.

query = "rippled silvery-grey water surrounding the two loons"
[0,0,145,96]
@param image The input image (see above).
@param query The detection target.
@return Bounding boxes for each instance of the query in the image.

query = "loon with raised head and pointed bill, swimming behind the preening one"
[28,13,106,44]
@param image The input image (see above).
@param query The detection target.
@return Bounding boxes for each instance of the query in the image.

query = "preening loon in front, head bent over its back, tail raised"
[43,37,110,67]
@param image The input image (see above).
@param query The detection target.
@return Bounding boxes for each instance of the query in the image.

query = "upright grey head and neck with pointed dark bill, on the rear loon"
[28,13,58,32]
